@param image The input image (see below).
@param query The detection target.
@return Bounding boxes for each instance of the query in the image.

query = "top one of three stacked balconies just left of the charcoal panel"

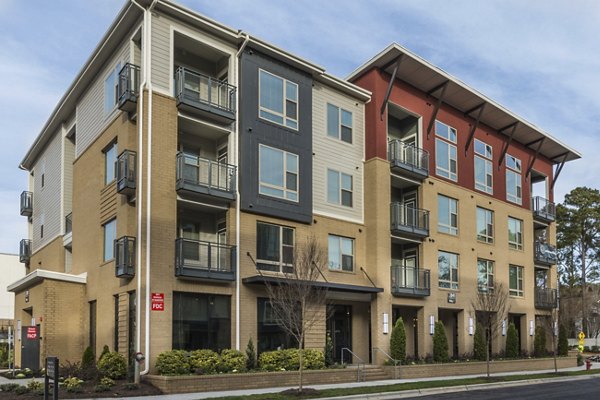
[175,67,237,124]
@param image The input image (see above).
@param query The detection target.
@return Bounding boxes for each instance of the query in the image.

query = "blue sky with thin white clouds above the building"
[0,0,600,253]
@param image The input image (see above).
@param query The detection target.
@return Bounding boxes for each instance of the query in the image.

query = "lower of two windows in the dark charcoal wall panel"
[258,144,298,201]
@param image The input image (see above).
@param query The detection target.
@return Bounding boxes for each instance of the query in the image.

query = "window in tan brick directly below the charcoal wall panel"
[256,222,294,273]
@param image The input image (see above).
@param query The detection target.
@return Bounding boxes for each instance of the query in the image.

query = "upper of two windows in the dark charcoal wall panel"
[258,70,298,129]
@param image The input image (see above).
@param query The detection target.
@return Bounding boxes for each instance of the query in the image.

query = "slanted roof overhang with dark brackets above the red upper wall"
[347,43,581,164]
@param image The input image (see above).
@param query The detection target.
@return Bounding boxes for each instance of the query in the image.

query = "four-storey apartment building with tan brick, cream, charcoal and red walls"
[9,0,579,373]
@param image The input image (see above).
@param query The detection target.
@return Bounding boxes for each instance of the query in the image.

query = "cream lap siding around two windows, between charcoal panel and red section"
[313,83,365,223]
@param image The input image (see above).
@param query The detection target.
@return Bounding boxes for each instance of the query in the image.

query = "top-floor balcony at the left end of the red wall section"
[388,140,429,181]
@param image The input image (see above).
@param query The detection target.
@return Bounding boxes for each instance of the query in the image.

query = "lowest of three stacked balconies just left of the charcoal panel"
[175,238,235,282]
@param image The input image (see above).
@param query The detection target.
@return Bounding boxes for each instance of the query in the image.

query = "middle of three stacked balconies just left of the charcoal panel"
[176,153,236,204]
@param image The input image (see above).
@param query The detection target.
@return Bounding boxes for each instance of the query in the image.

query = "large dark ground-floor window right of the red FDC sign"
[173,292,231,351]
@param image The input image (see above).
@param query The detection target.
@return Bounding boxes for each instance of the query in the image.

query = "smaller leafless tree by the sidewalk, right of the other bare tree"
[471,283,510,378]
